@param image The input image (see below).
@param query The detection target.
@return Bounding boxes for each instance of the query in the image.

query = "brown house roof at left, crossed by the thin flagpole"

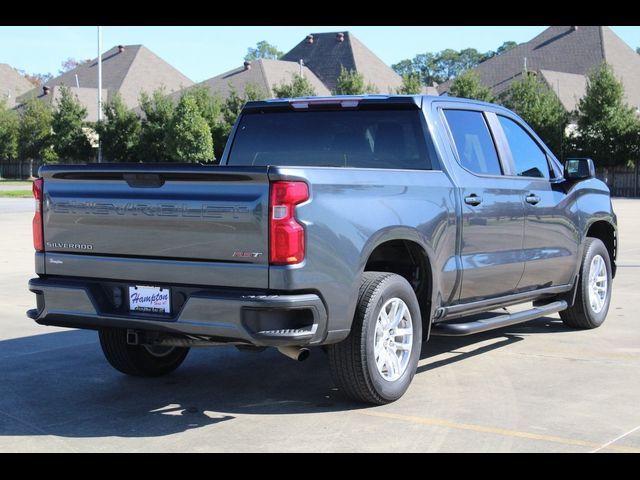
[33,45,193,108]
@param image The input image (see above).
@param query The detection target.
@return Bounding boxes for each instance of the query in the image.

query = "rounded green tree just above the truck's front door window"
[501,75,569,158]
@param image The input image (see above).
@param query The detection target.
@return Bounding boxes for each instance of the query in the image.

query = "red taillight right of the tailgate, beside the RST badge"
[269,182,309,265]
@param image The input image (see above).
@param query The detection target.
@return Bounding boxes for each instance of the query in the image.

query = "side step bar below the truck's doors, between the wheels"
[431,300,567,337]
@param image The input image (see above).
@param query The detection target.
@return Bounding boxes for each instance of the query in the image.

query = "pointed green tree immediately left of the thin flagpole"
[51,87,93,161]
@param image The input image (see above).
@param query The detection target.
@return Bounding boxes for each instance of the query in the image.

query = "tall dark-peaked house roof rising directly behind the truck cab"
[281,32,402,93]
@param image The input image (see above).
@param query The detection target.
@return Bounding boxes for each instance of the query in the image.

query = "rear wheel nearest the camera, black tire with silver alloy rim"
[329,272,422,405]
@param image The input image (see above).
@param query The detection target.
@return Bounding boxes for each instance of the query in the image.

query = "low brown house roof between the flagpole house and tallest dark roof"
[172,59,330,99]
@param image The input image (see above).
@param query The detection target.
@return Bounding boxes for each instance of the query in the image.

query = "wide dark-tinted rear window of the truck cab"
[228,110,432,170]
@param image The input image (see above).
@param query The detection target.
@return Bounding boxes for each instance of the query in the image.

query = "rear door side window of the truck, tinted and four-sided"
[444,110,502,175]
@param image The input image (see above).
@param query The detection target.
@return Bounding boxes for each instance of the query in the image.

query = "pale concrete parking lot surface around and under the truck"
[0,199,640,453]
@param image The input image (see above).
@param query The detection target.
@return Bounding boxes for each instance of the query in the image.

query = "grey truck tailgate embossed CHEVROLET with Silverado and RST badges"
[40,164,269,287]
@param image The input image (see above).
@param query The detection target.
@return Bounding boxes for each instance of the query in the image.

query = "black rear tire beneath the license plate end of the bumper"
[99,328,189,377]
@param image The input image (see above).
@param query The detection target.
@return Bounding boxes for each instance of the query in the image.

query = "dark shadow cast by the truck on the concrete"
[0,318,564,438]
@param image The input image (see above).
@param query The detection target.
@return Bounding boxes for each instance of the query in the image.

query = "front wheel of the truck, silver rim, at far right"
[560,237,611,329]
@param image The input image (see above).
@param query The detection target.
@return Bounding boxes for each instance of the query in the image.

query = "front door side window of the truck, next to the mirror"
[498,115,550,178]
